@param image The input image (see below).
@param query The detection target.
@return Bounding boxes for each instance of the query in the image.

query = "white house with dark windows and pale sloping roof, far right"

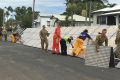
[93,5,120,25]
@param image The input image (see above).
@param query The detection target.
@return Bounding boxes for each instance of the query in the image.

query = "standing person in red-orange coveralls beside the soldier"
[52,23,61,54]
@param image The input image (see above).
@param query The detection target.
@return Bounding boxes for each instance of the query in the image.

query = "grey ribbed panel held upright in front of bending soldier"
[85,45,111,68]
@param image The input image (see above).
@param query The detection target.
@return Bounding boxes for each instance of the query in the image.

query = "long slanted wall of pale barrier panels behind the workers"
[21,26,116,53]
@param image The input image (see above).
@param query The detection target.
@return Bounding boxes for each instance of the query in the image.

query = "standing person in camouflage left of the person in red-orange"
[39,25,49,51]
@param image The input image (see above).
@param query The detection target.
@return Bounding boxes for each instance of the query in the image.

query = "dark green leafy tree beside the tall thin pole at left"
[15,6,39,28]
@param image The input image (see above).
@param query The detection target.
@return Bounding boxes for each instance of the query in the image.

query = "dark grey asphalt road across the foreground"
[0,42,120,80]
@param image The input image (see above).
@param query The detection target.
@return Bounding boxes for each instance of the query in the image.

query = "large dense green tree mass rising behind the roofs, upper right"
[64,0,108,26]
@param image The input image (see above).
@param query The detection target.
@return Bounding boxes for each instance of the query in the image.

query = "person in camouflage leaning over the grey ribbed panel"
[95,29,108,52]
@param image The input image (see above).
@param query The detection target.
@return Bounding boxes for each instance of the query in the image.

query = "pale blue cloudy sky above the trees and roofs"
[0,0,120,14]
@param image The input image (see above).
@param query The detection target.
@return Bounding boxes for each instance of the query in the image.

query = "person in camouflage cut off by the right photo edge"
[115,25,120,58]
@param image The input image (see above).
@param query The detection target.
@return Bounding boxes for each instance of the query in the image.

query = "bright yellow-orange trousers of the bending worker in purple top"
[72,36,85,58]
